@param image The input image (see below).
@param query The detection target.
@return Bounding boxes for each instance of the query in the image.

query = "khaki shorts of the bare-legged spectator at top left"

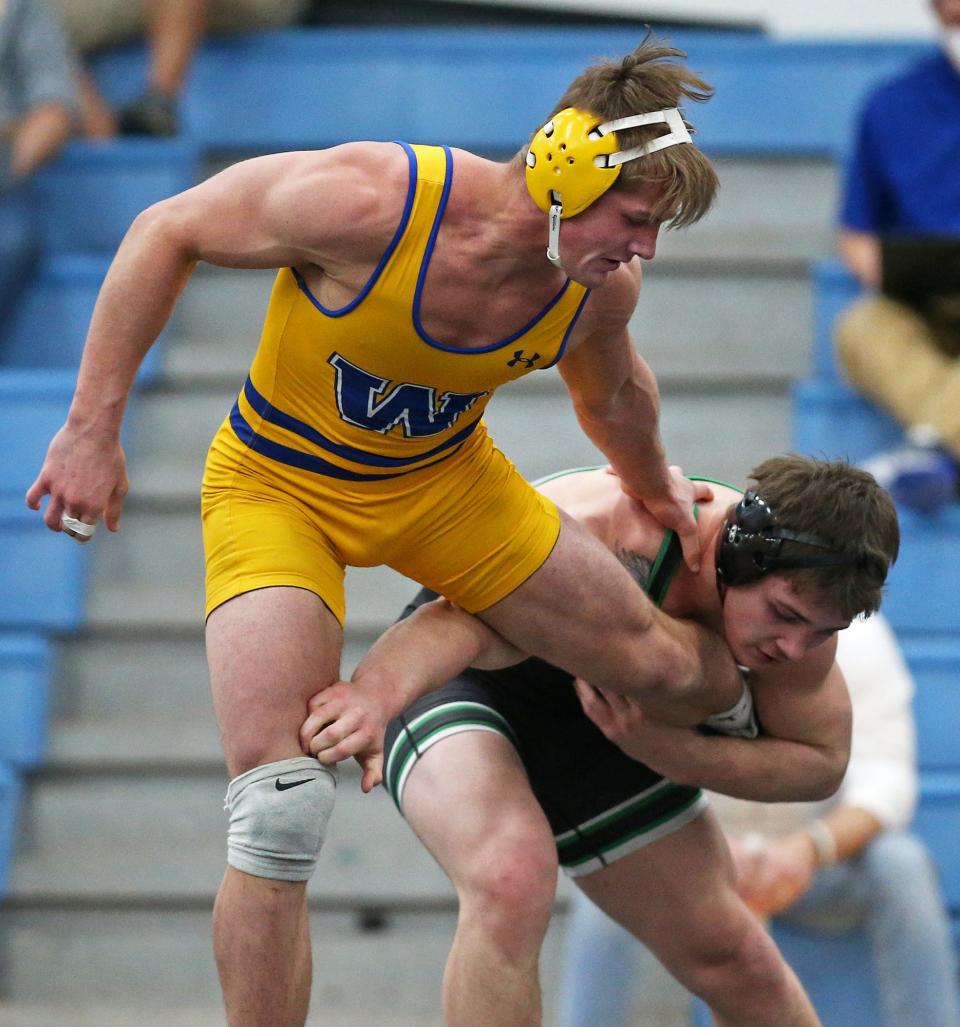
[51,0,307,53]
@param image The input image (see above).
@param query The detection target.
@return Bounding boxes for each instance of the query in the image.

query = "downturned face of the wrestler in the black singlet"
[723,574,849,671]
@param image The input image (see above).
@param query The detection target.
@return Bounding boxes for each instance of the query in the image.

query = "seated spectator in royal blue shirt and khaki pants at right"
[836,0,960,510]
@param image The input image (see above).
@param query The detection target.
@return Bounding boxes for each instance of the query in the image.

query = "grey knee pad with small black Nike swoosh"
[224,756,337,881]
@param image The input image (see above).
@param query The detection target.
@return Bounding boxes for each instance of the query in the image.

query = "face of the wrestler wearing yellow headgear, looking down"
[560,188,660,289]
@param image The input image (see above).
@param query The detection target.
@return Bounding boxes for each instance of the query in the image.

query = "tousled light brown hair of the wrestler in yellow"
[517,35,720,228]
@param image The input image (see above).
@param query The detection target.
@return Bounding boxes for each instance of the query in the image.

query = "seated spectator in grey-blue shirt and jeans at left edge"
[0,0,77,317]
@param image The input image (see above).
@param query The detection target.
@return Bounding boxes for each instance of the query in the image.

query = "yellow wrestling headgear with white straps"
[527,107,692,267]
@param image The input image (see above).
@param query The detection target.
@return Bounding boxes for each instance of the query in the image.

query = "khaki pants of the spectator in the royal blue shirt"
[835,296,960,459]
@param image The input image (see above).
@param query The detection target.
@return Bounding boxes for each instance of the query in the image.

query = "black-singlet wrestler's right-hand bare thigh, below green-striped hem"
[577,810,755,983]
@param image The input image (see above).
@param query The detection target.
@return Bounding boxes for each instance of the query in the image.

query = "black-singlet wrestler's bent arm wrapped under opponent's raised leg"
[578,663,852,802]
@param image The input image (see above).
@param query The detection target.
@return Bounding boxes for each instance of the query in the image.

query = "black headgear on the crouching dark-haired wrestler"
[717,489,860,595]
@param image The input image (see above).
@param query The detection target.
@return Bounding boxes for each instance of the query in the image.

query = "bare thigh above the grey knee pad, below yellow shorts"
[206,586,343,776]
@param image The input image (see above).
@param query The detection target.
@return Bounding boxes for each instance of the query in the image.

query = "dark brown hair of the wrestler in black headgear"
[750,454,900,619]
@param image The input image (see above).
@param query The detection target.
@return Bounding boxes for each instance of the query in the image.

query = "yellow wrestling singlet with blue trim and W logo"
[202,144,588,624]
